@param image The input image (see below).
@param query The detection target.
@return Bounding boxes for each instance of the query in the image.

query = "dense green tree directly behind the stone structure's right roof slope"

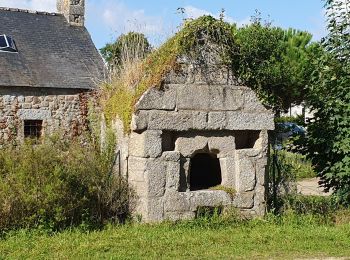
[233,21,317,112]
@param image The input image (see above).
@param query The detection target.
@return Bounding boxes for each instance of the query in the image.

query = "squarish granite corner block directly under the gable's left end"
[129,130,162,158]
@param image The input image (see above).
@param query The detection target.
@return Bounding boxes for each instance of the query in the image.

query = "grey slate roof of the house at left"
[0,8,104,89]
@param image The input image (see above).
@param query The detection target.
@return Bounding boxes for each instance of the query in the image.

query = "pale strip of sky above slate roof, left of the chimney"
[0,0,56,12]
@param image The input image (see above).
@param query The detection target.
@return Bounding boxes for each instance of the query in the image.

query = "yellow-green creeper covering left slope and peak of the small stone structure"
[102,16,234,133]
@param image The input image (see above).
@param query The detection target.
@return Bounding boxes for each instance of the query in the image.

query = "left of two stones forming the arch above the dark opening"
[175,135,208,157]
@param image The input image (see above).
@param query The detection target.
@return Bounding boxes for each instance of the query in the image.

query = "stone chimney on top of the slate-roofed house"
[57,0,85,26]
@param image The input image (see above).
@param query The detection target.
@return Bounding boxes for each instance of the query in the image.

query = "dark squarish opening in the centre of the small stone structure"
[190,153,221,191]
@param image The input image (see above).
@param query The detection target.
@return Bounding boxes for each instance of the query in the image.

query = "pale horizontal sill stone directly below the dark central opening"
[190,190,232,211]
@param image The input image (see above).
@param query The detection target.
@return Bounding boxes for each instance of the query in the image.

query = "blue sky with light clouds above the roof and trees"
[0,0,326,48]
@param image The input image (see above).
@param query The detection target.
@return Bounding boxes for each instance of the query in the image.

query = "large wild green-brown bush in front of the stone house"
[0,134,131,230]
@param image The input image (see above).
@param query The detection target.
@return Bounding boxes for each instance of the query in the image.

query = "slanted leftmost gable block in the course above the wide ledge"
[135,85,176,110]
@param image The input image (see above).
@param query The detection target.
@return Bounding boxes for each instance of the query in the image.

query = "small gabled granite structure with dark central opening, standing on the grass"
[117,55,274,222]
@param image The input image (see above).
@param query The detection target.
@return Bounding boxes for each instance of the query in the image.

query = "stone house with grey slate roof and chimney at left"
[0,0,104,146]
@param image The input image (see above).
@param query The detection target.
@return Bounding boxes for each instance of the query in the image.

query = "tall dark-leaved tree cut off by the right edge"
[306,0,350,204]
